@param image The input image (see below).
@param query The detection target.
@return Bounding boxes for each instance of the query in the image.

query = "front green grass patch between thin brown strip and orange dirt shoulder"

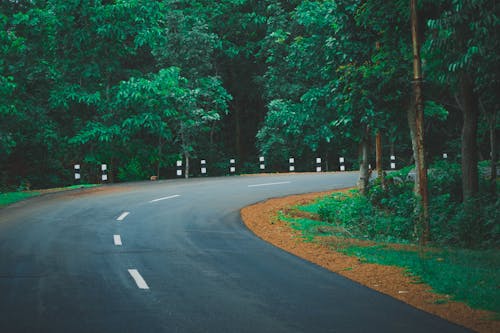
[342,246,500,312]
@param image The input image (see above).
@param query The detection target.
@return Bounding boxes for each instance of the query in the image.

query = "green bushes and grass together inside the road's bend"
[280,161,500,312]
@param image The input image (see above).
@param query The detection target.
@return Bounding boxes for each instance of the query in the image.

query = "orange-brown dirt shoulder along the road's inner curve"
[241,191,500,332]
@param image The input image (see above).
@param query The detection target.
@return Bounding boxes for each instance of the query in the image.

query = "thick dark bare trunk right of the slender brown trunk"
[460,74,479,201]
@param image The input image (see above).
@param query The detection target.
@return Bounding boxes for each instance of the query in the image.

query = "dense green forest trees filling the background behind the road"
[0,0,500,189]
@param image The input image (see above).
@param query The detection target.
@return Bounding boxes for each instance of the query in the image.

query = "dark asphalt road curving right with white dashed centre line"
[0,173,467,333]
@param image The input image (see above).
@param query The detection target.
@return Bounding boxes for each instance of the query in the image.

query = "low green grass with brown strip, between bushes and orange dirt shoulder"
[279,198,500,317]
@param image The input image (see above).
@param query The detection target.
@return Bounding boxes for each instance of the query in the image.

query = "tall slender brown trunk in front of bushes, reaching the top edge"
[410,0,430,245]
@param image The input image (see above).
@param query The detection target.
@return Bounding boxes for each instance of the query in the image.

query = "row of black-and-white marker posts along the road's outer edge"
[74,153,454,182]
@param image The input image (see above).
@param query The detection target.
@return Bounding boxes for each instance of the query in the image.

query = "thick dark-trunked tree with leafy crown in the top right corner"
[426,0,499,201]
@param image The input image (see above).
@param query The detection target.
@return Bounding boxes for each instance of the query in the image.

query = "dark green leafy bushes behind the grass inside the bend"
[318,161,500,248]
